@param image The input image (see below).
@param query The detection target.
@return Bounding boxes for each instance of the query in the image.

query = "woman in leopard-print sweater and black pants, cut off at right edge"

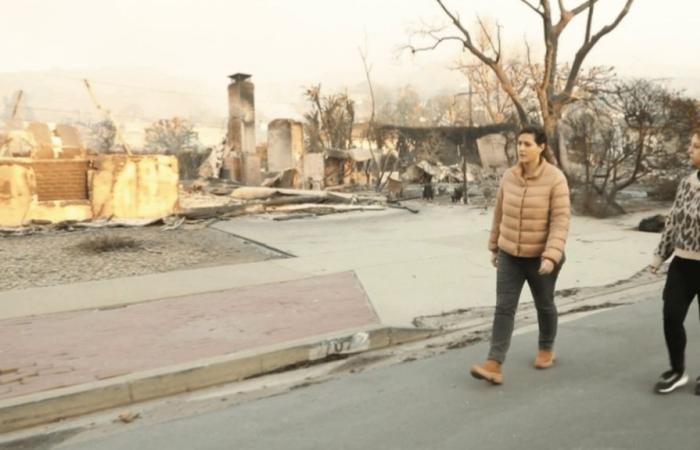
[651,130,700,395]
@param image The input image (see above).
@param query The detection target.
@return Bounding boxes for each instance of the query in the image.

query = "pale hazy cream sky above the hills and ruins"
[0,0,700,118]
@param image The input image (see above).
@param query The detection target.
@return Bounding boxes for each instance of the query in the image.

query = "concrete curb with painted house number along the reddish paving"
[0,325,442,433]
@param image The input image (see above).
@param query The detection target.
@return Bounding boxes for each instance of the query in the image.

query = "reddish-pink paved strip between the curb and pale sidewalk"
[0,272,378,399]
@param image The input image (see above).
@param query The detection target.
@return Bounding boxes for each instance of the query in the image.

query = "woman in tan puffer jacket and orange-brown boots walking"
[470,127,571,384]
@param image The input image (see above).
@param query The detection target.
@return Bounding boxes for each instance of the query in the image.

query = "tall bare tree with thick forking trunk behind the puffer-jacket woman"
[409,0,634,172]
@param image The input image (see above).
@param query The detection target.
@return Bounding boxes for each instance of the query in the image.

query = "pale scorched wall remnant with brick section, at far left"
[0,124,179,227]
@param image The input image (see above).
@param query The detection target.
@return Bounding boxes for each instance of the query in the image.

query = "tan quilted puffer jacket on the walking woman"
[489,160,571,264]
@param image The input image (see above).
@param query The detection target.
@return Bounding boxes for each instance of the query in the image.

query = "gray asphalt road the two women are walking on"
[56,297,700,450]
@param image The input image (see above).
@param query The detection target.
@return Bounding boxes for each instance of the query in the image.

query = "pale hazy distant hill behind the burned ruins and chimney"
[0,66,700,141]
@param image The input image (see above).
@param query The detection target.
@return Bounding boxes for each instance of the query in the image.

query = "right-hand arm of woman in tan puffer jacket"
[542,175,571,265]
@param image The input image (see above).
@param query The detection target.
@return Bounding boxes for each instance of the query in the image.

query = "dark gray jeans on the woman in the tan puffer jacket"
[488,250,566,363]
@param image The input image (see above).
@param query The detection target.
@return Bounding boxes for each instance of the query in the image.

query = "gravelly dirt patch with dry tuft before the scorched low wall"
[0,226,281,291]
